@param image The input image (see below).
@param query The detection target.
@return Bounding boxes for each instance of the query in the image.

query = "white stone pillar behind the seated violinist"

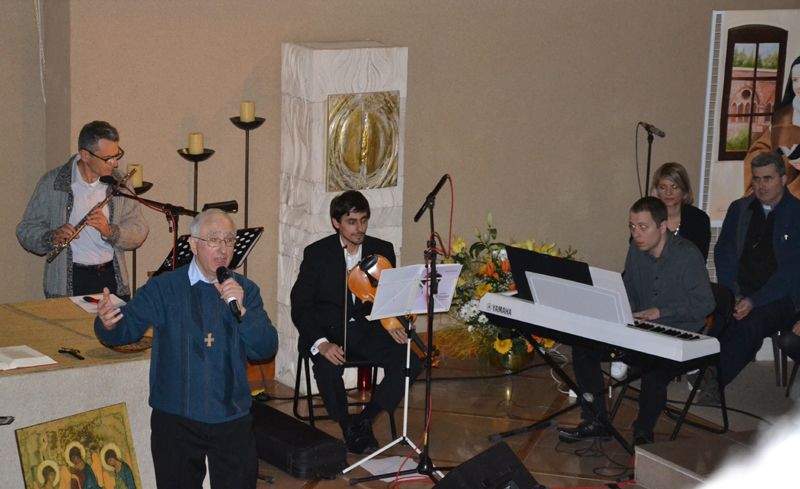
[275,41,408,391]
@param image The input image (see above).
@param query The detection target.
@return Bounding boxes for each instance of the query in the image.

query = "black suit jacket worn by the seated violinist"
[291,233,395,351]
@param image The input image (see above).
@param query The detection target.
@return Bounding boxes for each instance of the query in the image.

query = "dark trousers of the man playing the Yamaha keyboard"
[572,346,686,437]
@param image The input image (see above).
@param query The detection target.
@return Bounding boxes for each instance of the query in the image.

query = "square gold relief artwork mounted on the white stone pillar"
[326,92,400,192]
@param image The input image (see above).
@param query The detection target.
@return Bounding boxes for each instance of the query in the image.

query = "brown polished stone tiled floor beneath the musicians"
[248,348,800,488]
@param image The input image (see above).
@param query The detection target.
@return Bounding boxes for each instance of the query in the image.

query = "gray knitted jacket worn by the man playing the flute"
[17,155,149,297]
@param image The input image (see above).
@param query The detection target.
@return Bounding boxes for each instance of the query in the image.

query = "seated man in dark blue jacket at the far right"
[714,153,800,385]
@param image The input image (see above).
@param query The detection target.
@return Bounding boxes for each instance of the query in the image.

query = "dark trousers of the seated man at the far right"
[719,297,797,385]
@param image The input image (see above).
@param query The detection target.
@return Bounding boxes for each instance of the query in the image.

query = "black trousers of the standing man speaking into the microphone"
[150,409,258,489]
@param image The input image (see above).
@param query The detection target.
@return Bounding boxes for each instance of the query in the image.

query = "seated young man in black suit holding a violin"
[291,190,420,453]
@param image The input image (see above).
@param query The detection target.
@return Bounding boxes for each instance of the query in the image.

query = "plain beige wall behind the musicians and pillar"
[0,0,800,309]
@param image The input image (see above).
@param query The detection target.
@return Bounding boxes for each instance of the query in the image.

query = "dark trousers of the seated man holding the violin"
[311,323,422,424]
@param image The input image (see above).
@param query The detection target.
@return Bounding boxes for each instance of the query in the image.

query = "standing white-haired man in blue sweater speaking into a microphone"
[94,209,278,489]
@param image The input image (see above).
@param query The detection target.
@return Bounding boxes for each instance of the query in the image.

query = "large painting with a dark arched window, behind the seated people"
[695,9,800,222]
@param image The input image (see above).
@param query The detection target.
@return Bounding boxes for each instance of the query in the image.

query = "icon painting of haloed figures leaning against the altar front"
[16,403,142,489]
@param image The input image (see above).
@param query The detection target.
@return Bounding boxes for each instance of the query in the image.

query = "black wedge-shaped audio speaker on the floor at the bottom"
[435,442,546,489]
